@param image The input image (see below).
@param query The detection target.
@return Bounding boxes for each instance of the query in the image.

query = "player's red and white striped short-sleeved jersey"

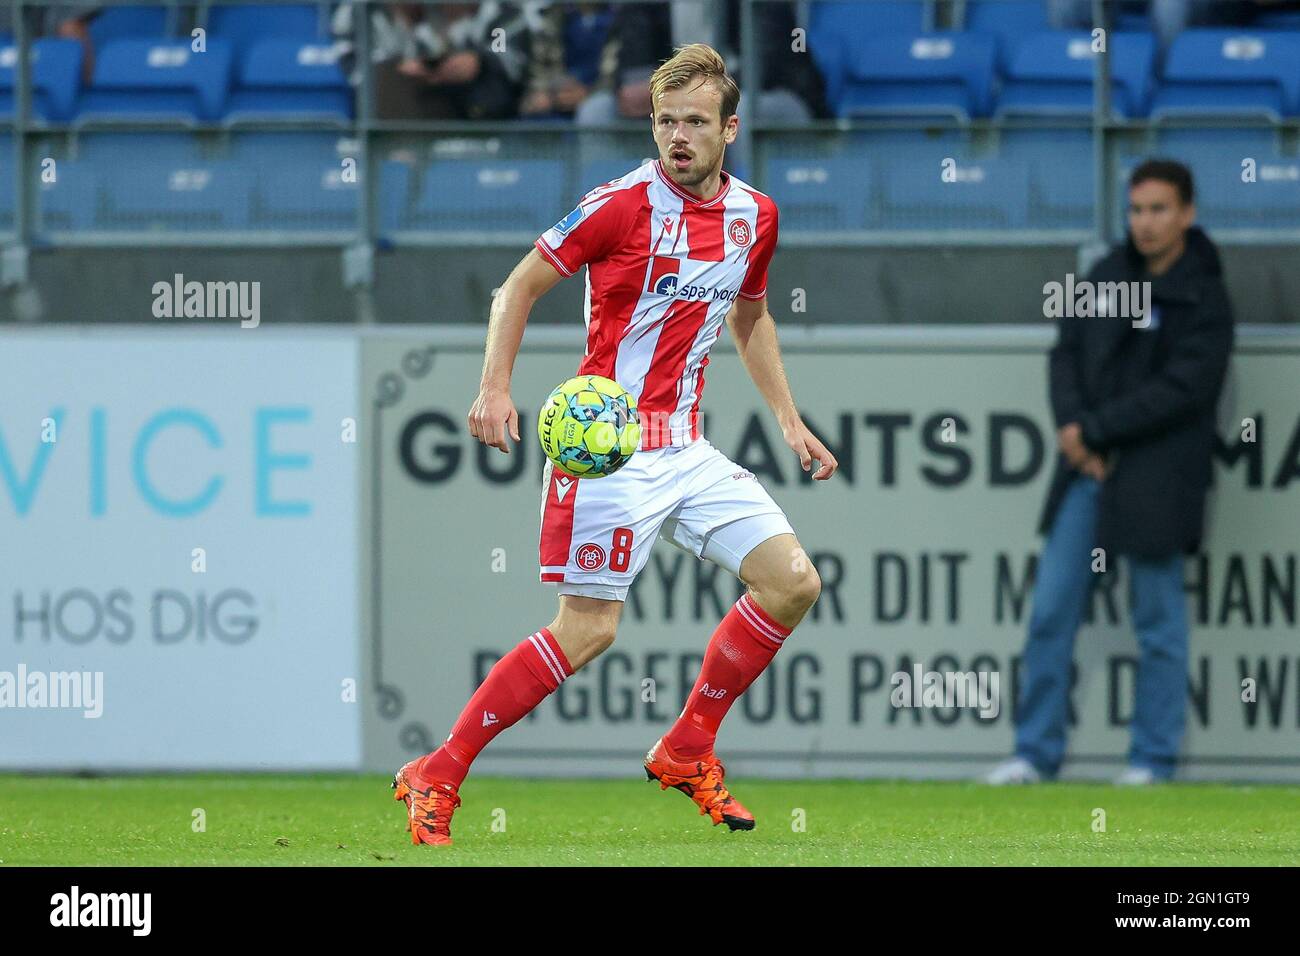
[534,160,777,450]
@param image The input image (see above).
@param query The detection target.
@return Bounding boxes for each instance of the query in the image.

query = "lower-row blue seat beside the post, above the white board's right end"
[230,133,361,230]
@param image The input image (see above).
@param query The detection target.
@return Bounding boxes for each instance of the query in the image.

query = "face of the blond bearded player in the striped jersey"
[650,77,740,189]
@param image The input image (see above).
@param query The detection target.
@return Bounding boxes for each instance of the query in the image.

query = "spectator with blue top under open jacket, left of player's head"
[519,4,614,117]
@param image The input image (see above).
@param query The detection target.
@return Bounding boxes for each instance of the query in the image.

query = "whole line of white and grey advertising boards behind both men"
[0,321,1300,780]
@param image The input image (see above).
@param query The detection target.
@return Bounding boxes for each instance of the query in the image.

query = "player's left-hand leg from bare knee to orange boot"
[393,594,623,845]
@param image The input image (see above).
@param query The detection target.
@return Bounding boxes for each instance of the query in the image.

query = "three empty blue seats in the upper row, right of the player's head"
[810,20,1300,121]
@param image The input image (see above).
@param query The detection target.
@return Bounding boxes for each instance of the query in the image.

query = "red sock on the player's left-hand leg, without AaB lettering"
[417,627,573,787]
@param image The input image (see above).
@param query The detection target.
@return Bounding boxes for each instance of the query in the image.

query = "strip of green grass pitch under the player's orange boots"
[0,774,1300,866]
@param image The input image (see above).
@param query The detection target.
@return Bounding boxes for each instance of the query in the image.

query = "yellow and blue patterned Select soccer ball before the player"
[537,375,641,477]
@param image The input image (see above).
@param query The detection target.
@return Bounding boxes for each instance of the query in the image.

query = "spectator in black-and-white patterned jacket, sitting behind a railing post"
[330,0,533,120]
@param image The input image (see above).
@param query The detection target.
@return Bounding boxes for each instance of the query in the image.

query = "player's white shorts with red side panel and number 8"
[540,438,794,601]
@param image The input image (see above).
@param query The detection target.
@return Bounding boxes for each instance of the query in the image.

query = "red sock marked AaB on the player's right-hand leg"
[664,594,790,760]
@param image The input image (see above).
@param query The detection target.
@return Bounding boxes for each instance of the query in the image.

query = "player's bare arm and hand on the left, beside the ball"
[469,247,564,455]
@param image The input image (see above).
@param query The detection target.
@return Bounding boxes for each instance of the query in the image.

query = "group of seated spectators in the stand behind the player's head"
[332,0,827,125]
